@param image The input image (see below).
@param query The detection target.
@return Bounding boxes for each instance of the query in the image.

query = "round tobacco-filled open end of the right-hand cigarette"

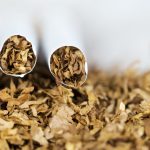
[50,46,87,88]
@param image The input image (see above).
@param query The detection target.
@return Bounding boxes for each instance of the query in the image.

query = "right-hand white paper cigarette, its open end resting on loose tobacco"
[43,8,88,88]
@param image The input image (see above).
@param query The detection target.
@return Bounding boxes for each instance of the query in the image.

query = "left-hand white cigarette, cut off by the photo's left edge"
[0,11,38,77]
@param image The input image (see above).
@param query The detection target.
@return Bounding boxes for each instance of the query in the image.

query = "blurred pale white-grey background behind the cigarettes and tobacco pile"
[0,0,150,71]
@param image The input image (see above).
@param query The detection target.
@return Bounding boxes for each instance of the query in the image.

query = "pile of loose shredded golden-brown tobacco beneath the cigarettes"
[0,69,150,150]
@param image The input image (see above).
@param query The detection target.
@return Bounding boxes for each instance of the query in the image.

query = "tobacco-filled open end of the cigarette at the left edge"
[0,35,36,76]
